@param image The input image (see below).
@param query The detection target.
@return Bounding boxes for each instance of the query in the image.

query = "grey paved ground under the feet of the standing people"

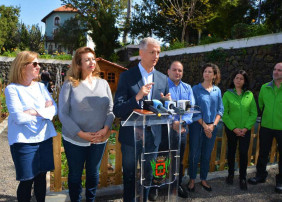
[0,117,282,202]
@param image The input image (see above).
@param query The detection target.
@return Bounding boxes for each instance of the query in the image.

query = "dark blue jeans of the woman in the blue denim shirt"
[188,122,217,180]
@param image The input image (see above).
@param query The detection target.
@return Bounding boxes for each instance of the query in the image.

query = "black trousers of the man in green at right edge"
[256,127,282,183]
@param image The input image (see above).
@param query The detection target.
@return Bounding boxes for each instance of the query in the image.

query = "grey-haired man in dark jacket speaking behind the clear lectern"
[113,37,170,202]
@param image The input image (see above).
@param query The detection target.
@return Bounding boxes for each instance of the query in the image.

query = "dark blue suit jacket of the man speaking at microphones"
[113,66,169,146]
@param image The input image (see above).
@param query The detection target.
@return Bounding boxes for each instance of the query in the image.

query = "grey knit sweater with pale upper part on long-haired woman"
[58,79,114,143]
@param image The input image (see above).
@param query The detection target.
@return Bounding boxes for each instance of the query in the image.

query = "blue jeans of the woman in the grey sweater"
[63,140,106,202]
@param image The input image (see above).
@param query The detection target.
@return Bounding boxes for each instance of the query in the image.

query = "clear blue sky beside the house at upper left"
[0,0,140,34]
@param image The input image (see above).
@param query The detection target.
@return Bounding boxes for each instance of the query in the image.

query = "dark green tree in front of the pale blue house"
[54,17,86,53]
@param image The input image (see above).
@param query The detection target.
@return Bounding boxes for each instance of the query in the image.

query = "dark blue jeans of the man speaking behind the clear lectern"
[121,132,158,202]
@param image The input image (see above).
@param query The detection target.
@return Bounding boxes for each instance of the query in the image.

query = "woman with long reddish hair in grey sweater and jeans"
[59,47,114,201]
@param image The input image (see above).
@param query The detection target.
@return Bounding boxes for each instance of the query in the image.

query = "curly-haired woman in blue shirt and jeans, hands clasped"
[188,63,223,191]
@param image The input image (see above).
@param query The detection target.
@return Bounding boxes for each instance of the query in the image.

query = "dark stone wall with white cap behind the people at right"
[127,43,282,98]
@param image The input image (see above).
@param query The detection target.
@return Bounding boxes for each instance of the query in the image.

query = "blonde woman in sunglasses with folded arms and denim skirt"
[5,51,57,201]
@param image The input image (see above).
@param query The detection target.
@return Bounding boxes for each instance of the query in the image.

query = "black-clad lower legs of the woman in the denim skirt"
[17,172,46,202]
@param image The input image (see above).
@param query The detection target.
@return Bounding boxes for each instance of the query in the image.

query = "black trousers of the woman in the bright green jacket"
[225,127,251,179]
